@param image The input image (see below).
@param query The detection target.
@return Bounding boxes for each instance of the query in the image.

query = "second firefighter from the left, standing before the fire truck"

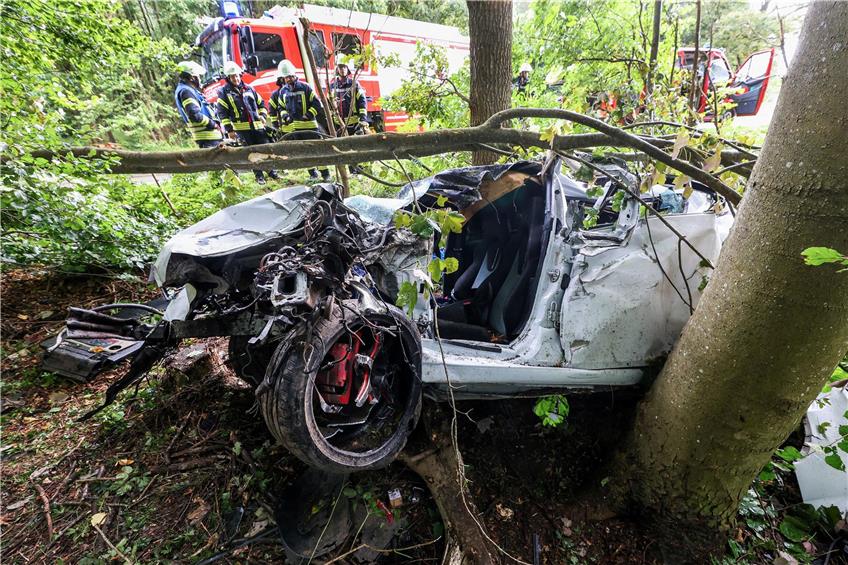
[218,61,280,184]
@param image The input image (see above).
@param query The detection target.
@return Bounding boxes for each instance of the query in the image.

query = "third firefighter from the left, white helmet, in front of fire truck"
[271,59,330,181]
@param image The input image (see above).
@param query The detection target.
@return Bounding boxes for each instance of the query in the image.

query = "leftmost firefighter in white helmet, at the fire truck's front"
[174,61,223,149]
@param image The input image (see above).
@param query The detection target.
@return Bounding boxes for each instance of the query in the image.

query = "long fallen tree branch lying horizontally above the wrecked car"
[24,108,741,204]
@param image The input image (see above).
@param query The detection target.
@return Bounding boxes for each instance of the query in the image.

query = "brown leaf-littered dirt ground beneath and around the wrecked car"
[0,271,839,564]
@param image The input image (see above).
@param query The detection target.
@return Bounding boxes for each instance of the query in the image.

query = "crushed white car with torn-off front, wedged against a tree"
[45,154,732,472]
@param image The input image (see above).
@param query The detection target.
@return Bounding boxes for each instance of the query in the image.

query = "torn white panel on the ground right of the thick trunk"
[795,383,848,512]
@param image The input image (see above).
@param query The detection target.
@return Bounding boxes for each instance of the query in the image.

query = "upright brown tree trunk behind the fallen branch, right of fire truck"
[468,0,512,165]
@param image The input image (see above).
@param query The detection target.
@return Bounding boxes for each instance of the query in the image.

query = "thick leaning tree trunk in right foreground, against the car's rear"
[617,2,848,551]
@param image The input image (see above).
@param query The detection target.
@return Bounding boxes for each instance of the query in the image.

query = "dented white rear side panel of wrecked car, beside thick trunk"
[560,209,732,369]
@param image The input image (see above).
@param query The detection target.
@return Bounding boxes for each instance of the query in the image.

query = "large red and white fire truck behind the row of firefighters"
[196,3,469,131]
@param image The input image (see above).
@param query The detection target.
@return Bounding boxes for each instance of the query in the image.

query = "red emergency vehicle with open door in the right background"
[675,47,774,118]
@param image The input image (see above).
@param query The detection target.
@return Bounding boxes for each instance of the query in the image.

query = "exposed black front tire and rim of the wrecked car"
[257,301,421,473]
